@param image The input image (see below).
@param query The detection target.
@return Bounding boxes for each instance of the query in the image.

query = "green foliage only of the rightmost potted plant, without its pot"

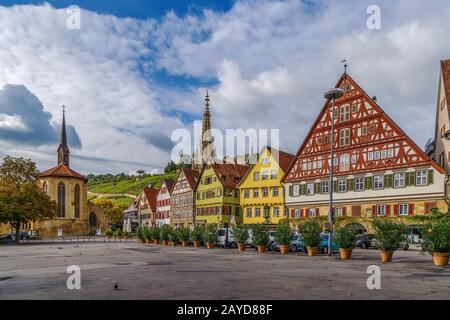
[422,217,450,254]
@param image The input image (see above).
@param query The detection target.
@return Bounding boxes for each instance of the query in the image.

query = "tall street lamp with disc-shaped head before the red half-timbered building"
[324,88,344,256]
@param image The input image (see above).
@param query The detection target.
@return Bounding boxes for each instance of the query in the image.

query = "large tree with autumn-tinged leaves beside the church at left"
[0,157,57,243]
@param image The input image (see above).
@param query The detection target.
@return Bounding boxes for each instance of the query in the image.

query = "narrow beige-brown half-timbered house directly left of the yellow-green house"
[170,168,199,227]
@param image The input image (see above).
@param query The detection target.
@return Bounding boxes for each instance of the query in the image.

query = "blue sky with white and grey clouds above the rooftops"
[0,0,450,174]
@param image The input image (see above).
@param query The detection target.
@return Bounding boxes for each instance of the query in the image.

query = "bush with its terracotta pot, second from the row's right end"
[372,218,406,263]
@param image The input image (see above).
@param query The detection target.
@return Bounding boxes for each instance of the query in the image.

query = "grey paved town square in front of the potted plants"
[0,243,450,300]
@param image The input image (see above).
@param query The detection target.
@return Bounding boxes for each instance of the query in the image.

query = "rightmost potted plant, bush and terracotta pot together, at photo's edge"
[422,217,450,267]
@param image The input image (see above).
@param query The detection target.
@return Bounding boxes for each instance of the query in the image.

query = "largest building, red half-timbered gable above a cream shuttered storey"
[283,73,447,234]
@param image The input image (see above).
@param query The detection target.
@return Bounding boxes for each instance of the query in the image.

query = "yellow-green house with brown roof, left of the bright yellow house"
[195,164,248,227]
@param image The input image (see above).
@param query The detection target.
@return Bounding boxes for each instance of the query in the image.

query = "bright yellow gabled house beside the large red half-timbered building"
[238,147,295,225]
